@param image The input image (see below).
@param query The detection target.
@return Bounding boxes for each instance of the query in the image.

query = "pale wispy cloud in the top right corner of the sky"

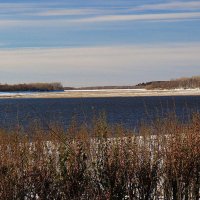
[132,1,200,11]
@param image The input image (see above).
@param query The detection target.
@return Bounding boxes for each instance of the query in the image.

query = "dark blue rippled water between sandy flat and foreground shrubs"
[0,96,200,128]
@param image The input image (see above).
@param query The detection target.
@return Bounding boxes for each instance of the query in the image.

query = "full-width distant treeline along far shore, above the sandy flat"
[0,76,200,92]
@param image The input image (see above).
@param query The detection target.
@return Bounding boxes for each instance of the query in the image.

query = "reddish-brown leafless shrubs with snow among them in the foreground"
[0,113,200,200]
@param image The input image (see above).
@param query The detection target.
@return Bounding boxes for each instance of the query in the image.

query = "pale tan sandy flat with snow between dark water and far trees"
[0,89,200,99]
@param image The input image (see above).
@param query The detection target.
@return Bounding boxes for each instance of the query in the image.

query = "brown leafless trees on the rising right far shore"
[136,76,200,90]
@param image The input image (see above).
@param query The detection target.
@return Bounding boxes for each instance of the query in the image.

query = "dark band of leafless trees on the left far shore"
[0,83,64,92]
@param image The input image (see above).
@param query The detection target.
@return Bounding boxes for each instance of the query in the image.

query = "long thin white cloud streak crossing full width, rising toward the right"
[0,12,200,29]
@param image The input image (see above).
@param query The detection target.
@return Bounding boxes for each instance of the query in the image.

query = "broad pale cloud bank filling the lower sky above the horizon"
[0,43,200,85]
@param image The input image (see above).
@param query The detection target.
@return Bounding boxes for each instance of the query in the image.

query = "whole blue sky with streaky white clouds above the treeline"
[0,0,200,87]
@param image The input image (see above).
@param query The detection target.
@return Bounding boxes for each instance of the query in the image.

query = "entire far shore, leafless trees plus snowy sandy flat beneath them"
[0,76,200,99]
